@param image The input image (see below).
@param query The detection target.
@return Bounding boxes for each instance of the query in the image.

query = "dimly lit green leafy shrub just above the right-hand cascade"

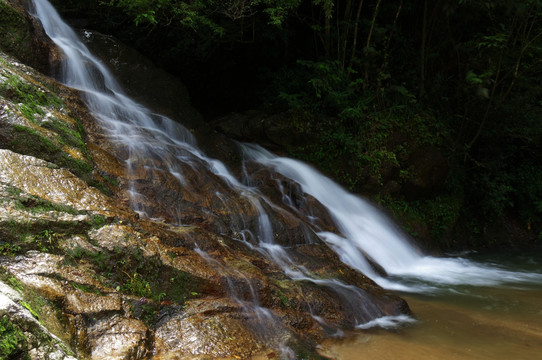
[277,61,446,191]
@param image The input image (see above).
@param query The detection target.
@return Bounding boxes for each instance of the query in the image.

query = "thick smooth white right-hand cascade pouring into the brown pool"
[244,145,542,292]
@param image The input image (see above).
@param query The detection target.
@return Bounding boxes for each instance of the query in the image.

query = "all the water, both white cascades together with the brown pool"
[29,0,542,359]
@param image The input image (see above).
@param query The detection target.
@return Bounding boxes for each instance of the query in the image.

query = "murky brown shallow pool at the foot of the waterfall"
[321,289,542,360]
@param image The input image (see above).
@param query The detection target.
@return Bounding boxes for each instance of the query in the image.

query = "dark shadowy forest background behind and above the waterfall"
[47,0,542,249]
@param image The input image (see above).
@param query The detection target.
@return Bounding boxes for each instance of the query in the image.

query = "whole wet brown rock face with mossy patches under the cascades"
[0,0,408,359]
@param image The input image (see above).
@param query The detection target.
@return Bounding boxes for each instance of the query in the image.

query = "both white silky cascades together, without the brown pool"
[33,0,542,334]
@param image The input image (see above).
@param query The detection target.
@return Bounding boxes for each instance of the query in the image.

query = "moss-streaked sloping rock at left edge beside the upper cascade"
[0,48,131,211]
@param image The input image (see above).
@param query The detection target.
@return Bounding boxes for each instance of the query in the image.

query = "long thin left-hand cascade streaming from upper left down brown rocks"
[28,0,383,325]
